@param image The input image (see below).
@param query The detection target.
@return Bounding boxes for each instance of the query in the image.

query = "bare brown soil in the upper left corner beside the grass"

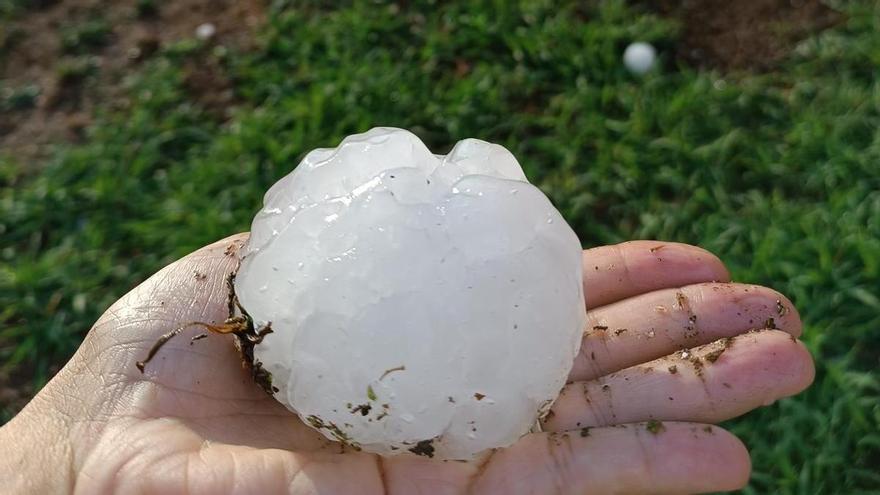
[0,0,265,166]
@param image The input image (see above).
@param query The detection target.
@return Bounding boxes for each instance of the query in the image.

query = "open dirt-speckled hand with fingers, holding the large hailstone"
[29,234,812,494]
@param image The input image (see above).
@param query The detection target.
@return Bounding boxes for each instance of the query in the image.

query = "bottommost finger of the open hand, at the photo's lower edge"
[473,422,750,494]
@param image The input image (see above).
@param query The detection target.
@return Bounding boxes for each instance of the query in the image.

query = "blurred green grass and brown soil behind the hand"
[0,0,880,493]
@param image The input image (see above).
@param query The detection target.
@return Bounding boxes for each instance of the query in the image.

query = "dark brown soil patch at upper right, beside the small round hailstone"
[641,0,842,71]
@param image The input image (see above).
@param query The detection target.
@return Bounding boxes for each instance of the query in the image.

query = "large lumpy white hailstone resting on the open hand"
[235,128,585,459]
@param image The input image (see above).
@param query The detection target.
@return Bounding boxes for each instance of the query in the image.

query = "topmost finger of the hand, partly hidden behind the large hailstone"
[583,241,730,309]
